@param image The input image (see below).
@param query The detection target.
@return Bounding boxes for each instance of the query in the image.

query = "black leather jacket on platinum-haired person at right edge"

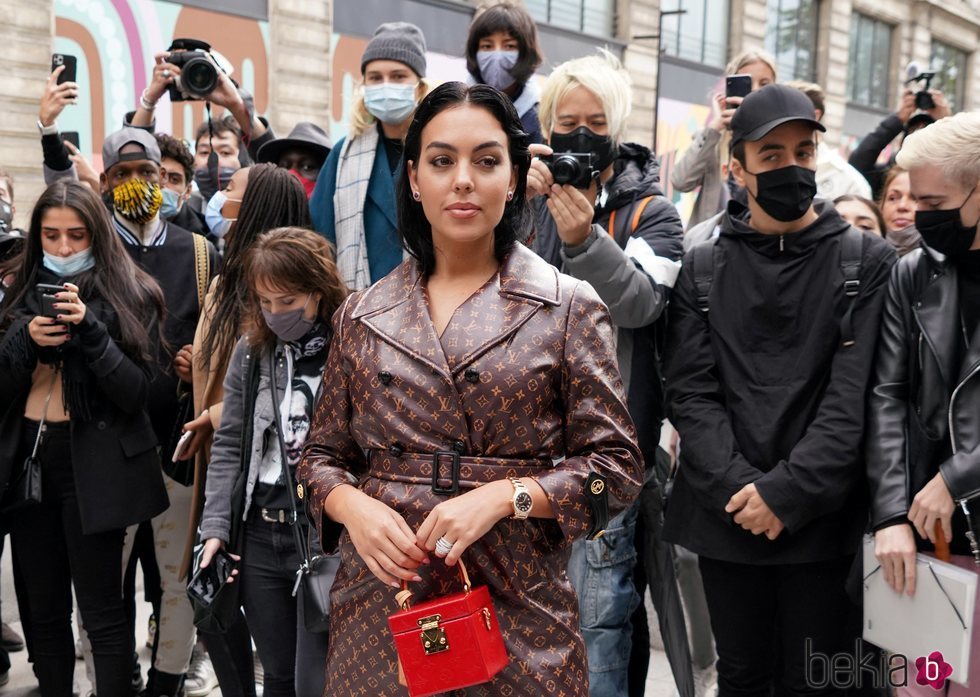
[867,248,980,542]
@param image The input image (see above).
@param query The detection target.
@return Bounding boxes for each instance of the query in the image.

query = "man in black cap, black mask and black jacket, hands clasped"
[663,85,895,697]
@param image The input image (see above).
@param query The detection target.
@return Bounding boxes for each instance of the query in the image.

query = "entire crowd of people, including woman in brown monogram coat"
[0,2,980,697]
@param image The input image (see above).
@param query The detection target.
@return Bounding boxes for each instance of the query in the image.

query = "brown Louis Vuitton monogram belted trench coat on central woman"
[297,245,643,697]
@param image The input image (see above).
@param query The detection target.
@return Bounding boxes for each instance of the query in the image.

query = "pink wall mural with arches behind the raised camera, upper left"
[54,0,269,169]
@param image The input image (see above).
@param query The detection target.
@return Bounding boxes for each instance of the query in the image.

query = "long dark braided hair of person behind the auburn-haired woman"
[198,162,313,373]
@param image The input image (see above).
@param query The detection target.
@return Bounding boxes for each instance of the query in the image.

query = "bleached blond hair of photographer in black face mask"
[538,48,633,145]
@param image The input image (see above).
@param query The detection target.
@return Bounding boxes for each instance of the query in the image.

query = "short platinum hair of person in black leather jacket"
[895,111,980,190]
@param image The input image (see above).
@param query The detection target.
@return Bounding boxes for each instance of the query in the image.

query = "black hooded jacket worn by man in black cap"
[664,202,895,564]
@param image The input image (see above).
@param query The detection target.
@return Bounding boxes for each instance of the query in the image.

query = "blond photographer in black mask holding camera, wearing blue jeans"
[527,51,689,697]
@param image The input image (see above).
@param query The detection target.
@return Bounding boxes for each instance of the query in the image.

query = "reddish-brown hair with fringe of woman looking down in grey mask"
[245,227,349,347]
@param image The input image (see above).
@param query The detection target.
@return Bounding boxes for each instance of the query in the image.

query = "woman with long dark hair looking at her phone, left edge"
[0,182,167,697]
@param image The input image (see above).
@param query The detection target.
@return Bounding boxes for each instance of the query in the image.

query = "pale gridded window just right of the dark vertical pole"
[660,0,728,68]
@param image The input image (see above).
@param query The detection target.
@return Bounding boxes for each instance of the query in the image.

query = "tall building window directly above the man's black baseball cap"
[766,0,819,82]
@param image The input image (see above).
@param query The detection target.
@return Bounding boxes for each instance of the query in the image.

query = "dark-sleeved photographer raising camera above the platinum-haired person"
[847,63,951,200]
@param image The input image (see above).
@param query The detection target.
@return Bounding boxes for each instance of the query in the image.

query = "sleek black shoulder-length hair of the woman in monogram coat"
[397,82,531,275]
